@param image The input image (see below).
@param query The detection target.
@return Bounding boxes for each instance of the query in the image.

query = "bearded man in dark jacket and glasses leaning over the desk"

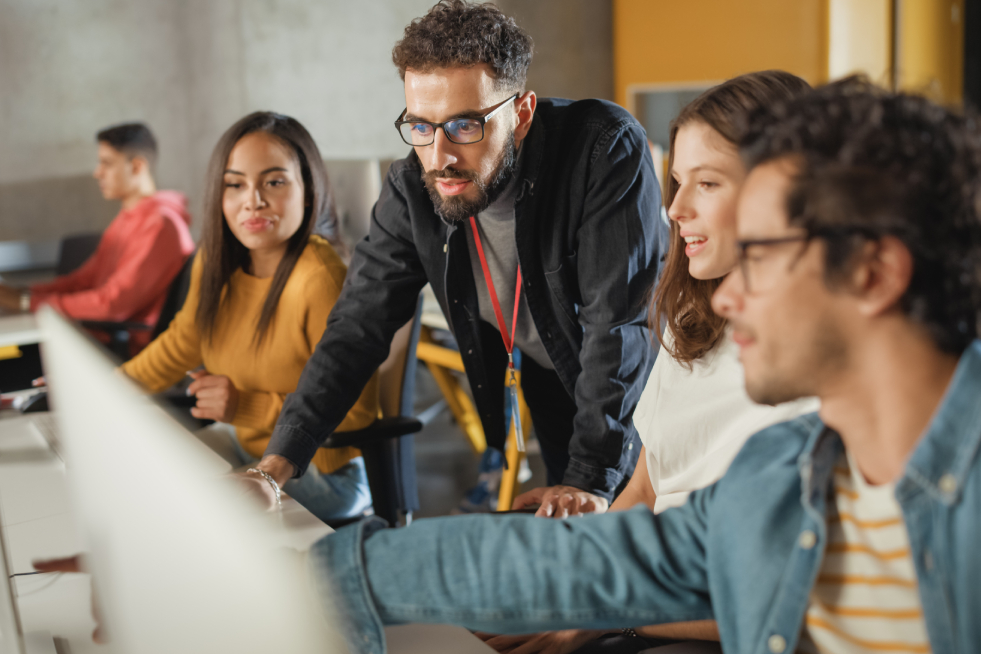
[253,0,666,513]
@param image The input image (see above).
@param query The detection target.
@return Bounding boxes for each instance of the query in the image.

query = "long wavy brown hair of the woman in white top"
[650,70,811,368]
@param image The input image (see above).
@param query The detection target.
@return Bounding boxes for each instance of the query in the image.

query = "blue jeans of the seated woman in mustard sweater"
[221,425,371,522]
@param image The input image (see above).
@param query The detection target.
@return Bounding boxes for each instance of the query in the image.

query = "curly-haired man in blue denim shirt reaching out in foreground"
[309,79,981,654]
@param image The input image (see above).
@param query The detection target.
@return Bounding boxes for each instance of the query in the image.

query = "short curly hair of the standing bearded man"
[392,0,534,92]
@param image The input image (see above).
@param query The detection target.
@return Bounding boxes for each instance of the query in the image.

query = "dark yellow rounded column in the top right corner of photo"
[897,0,964,104]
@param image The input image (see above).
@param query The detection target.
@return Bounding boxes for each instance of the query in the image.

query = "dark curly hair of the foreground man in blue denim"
[741,77,981,353]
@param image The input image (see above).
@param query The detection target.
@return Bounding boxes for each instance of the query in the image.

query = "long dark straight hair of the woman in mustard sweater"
[196,111,344,348]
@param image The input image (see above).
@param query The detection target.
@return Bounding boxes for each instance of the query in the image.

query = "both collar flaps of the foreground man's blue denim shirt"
[797,341,981,517]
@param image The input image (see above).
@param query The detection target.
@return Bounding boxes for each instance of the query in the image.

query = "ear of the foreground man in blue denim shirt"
[852,236,913,316]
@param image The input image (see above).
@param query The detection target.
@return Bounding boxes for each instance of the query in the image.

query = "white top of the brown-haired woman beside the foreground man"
[634,330,820,513]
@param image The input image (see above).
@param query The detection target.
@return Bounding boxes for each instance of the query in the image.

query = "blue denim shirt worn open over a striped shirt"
[309,341,981,654]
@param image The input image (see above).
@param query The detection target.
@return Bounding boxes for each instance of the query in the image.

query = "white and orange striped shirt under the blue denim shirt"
[798,455,930,654]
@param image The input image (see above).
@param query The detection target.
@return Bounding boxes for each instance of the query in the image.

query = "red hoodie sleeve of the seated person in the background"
[38,214,184,321]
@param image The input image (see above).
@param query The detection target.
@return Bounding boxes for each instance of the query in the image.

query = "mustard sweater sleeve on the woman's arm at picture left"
[123,254,202,393]
